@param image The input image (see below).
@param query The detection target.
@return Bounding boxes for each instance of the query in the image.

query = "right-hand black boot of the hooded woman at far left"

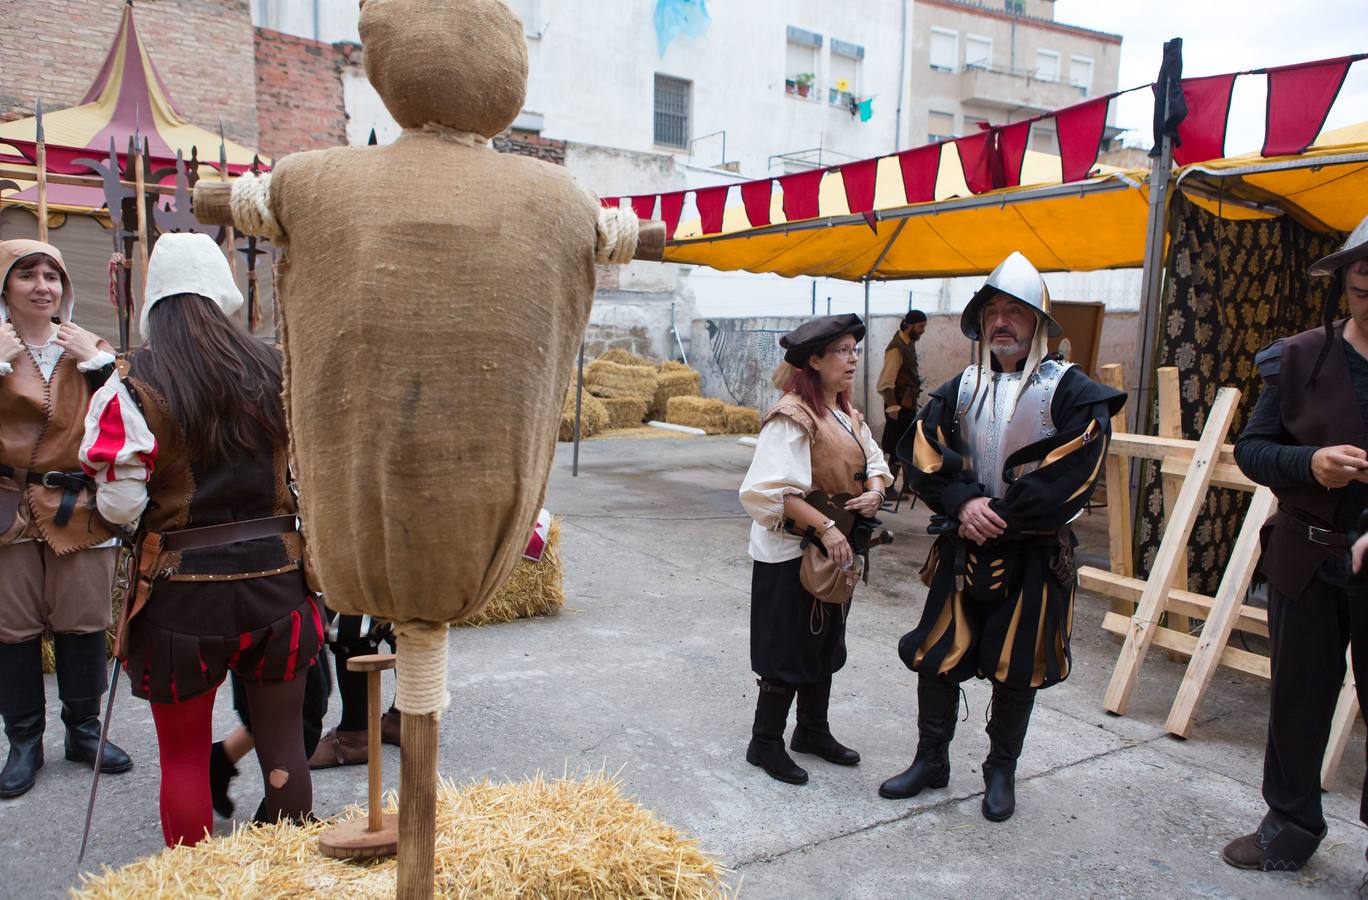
[52,631,133,773]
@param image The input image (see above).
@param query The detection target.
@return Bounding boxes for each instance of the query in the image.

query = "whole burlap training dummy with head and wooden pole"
[198,0,636,896]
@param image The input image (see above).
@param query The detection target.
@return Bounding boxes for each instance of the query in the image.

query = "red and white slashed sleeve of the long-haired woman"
[81,372,157,525]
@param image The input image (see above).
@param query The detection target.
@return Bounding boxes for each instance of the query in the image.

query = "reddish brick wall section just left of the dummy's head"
[256,29,360,159]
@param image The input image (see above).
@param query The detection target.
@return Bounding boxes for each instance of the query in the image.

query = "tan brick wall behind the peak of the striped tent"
[0,0,257,145]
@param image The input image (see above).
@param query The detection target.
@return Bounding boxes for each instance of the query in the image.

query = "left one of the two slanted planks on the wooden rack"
[1103,387,1239,715]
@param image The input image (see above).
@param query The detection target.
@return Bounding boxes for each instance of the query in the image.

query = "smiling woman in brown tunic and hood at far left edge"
[0,241,133,797]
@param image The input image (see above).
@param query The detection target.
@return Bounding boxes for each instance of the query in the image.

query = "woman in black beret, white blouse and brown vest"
[740,315,891,784]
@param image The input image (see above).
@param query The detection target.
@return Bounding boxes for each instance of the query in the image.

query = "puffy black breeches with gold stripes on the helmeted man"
[897,536,1077,688]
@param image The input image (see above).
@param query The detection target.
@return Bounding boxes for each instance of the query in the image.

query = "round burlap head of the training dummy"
[361,0,527,137]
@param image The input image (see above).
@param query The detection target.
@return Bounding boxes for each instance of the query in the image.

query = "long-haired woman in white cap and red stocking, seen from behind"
[81,234,323,847]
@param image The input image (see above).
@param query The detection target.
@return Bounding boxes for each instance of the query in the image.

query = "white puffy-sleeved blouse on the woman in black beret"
[740,409,892,562]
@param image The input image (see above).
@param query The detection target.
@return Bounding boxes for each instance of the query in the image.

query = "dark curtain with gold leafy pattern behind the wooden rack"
[1135,193,1343,594]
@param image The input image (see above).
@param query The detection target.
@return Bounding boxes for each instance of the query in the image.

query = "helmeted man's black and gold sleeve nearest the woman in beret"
[897,376,985,516]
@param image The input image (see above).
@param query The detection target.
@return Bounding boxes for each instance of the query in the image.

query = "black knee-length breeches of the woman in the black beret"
[751,558,850,684]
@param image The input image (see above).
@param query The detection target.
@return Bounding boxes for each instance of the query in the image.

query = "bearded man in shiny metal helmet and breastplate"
[878,253,1126,822]
